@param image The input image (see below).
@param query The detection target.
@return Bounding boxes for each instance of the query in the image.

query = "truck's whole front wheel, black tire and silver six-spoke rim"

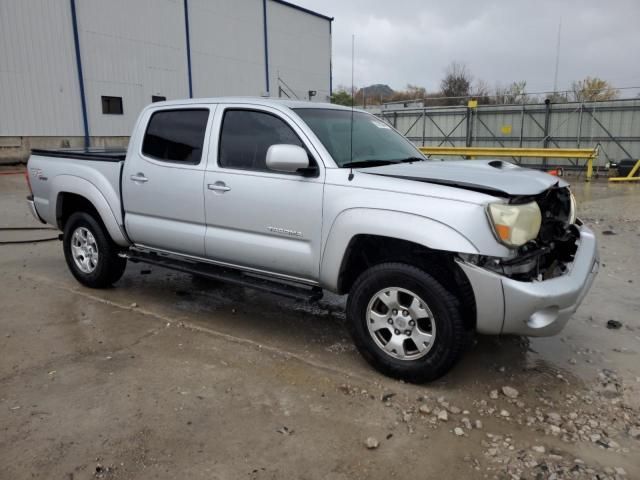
[347,263,467,383]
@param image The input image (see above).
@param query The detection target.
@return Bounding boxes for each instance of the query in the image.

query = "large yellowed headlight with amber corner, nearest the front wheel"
[488,202,542,247]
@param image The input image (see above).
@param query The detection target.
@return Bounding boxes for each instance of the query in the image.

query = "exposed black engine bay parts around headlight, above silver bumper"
[465,187,580,281]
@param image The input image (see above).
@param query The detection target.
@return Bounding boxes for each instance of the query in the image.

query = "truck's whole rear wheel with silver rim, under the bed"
[62,212,127,288]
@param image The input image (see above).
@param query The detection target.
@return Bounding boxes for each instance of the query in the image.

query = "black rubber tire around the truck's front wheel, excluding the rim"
[347,263,469,383]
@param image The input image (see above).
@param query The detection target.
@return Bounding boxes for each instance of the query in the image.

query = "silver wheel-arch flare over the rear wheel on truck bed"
[49,175,130,247]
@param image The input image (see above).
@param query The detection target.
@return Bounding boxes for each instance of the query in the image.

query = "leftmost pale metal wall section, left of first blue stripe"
[0,0,83,136]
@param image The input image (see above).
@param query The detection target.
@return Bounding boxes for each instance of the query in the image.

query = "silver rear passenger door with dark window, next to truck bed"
[122,106,214,256]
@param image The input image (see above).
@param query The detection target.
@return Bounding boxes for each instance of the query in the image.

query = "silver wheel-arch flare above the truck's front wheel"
[320,208,478,291]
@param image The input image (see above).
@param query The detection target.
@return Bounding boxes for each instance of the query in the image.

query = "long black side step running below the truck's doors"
[126,251,322,302]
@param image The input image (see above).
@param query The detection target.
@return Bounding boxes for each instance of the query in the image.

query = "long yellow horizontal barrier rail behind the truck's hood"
[418,147,596,182]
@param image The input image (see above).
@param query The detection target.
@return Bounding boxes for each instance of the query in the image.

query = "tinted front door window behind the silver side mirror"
[220,110,304,170]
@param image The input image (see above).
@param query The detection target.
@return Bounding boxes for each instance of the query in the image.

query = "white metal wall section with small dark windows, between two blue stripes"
[76,0,189,136]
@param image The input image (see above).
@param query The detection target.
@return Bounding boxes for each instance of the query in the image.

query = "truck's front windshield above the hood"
[295,108,426,167]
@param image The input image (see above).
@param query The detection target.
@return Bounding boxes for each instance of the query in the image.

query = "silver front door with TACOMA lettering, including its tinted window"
[204,105,324,280]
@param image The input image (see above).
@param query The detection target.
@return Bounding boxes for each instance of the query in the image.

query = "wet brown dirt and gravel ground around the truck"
[0,168,640,479]
